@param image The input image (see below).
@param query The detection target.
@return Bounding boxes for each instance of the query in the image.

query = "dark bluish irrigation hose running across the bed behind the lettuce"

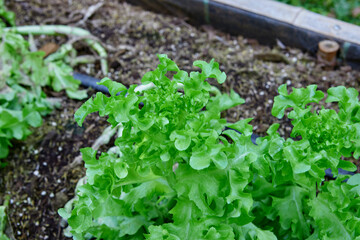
[73,73,355,179]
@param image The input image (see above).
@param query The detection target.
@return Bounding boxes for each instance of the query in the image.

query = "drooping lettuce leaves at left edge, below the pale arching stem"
[0,29,87,159]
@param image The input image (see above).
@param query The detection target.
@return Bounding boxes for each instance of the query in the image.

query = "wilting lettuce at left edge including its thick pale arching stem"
[0,0,108,161]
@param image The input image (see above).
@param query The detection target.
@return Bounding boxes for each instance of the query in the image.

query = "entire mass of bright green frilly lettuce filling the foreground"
[59,55,360,240]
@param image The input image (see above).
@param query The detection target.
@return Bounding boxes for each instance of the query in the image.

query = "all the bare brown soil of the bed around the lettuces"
[0,0,360,239]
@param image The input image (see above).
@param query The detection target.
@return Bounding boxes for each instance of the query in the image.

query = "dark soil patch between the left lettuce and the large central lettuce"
[0,88,108,239]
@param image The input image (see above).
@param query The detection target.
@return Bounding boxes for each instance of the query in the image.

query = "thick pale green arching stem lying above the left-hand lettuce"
[4,25,108,75]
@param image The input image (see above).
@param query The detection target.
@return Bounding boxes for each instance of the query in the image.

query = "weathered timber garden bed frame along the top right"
[125,0,360,69]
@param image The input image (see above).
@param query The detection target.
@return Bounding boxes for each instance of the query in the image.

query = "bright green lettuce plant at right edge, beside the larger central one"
[249,85,360,240]
